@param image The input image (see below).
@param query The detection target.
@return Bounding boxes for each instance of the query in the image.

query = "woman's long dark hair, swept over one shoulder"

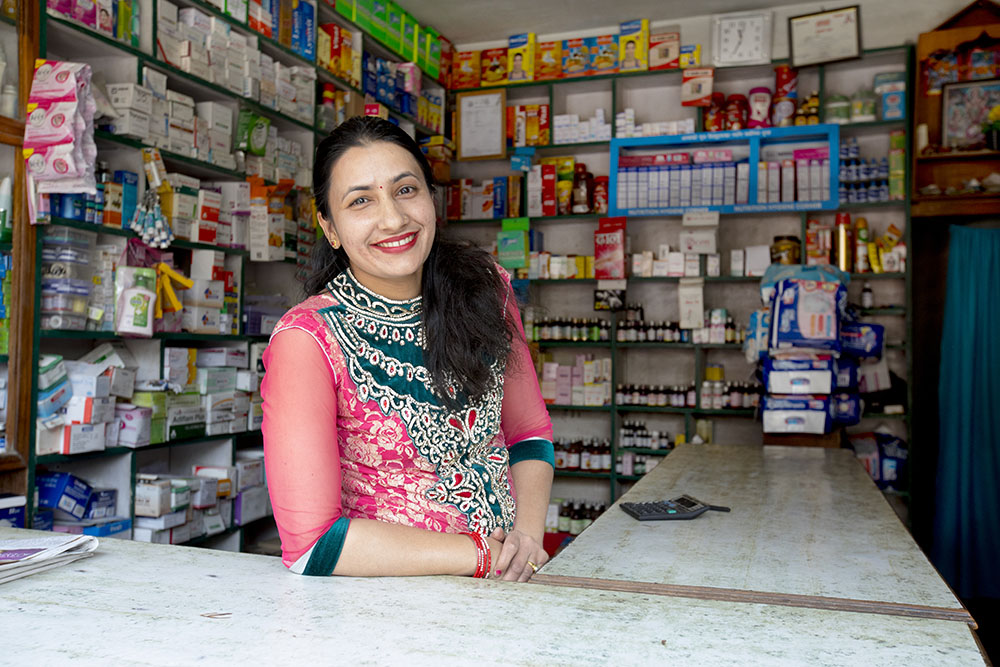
[305,116,516,407]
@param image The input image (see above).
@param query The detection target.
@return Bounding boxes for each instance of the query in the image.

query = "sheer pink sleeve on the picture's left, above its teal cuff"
[261,328,346,574]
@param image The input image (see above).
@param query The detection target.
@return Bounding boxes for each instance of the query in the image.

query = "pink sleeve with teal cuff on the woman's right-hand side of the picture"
[500,280,555,465]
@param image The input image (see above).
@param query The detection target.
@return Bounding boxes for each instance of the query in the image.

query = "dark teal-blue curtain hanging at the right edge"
[932,225,1000,598]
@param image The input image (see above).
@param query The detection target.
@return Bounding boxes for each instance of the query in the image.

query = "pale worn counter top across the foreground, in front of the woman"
[0,528,983,666]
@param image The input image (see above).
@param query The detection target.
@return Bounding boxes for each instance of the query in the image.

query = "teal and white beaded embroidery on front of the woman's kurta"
[317,271,515,534]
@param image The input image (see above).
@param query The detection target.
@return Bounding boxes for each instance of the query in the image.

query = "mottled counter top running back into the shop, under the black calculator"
[540,444,963,611]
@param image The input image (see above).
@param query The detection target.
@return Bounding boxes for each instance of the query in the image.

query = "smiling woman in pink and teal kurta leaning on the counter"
[261,118,553,581]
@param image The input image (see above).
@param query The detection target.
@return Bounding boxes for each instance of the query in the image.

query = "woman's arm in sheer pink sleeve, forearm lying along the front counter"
[261,328,501,576]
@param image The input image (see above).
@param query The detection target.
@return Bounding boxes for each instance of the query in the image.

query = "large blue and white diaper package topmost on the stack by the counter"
[768,278,847,355]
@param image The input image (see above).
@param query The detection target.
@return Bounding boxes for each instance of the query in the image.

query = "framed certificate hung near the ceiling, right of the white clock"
[788,5,861,67]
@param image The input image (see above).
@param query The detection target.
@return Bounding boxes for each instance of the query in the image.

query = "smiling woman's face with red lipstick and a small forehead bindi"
[319,141,436,299]
